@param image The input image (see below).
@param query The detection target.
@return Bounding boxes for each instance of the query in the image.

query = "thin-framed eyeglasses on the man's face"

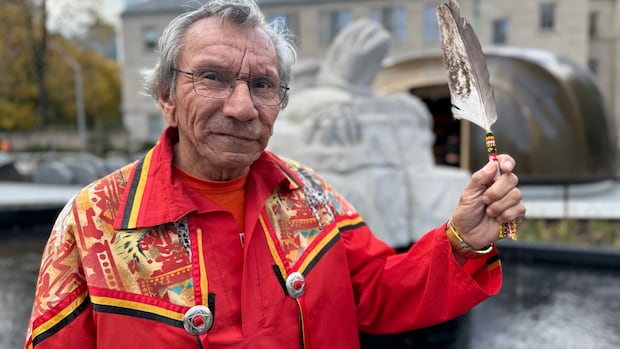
[173,68,289,106]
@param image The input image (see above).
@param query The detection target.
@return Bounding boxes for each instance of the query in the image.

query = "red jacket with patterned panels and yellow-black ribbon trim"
[26,129,501,349]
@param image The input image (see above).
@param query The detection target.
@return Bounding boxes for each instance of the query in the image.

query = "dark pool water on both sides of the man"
[0,227,620,349]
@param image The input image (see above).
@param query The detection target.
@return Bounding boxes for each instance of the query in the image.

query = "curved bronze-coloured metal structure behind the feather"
[375,47,618,184]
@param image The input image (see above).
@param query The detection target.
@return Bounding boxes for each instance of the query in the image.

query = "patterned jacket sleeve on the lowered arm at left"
[25,201,95,348]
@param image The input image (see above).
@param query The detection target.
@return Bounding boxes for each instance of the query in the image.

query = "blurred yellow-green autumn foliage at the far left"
[0,0,122,131]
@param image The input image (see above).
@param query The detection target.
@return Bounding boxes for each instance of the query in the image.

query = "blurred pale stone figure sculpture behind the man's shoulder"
[269,19,469,247]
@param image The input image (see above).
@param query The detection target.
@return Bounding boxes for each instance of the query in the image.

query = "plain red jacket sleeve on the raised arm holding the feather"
[343,219,502,333]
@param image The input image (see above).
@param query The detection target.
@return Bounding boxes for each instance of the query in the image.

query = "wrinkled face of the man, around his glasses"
[158,18,280,180]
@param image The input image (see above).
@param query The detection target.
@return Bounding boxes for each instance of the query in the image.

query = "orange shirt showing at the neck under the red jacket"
[173,166,248,232]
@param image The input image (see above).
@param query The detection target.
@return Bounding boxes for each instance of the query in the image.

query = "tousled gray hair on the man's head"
[142,0,297,108]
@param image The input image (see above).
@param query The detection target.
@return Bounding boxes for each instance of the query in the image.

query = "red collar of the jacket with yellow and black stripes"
[114,127,303,229]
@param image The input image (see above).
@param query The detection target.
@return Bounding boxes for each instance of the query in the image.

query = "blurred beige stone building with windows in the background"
[121,0,620,152]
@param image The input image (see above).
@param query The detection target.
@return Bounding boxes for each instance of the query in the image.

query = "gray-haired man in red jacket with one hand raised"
[26,0,525,349]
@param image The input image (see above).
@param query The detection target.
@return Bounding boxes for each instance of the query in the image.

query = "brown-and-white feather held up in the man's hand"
[437,0,497,132]
